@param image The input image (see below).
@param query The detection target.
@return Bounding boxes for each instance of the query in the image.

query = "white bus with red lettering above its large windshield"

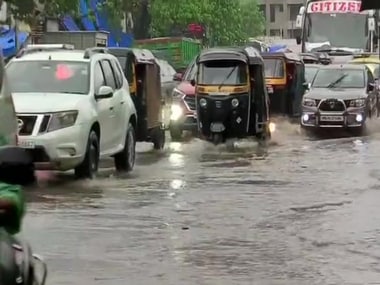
[296,0,378,55]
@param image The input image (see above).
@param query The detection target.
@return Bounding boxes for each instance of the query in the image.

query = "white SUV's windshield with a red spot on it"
[7,60,90,94]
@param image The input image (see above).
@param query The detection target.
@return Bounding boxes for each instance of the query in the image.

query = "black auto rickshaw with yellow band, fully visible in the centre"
[191,47,270,144]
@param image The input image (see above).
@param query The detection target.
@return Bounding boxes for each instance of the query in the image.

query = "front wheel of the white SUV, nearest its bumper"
[75,131,99,178]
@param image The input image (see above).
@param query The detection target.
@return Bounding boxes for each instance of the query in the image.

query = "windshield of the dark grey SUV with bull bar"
[312,69,365,88]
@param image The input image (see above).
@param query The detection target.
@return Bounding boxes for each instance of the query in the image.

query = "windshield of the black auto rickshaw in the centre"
[198,60,248,85]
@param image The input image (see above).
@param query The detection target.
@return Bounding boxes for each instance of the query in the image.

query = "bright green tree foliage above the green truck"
[151,0,264,45]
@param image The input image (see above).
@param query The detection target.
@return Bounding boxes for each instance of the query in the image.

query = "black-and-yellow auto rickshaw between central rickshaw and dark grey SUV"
[261,52,308,118]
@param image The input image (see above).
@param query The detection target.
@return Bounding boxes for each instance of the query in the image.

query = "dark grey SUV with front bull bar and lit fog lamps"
[301,64,377,134]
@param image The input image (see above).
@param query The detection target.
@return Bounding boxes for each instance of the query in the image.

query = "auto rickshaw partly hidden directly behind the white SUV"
[107,47,165,149]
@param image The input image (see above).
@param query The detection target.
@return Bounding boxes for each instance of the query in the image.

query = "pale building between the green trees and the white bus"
[258,0,305,38]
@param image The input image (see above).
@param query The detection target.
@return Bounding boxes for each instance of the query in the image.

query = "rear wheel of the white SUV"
[114,123,136,172]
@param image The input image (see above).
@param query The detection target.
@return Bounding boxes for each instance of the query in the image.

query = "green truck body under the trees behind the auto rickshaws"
[134,37,202,72]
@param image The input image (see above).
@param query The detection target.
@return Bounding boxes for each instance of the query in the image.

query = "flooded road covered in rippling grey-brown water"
[23,123,380,285]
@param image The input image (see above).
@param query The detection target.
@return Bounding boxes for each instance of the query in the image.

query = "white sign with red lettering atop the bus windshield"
[307,1,361,14]
